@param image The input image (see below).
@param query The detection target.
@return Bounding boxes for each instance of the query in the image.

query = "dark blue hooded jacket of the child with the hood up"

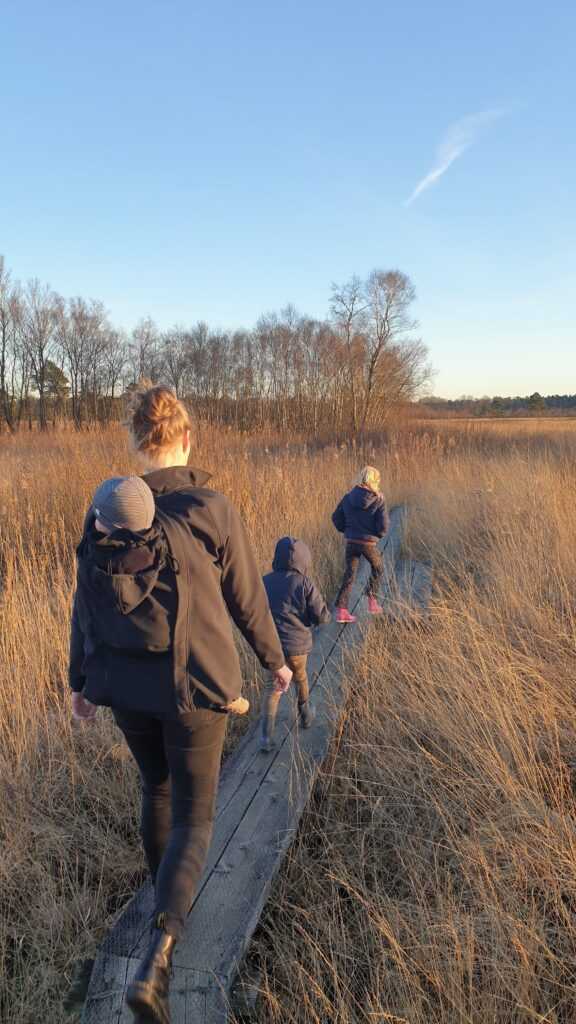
[263,537,331,656]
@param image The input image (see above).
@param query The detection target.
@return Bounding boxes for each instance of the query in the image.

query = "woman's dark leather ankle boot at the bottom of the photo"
[126,928,175,1024]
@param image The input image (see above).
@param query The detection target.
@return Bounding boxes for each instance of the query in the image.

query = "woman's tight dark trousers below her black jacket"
[114,708,228,939]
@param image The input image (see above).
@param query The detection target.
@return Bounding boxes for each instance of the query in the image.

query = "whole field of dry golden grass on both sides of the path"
[0,420,576,1024]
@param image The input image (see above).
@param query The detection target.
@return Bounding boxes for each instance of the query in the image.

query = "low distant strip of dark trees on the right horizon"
[418,391,576,417]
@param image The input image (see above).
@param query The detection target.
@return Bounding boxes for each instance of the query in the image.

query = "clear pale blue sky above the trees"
[0,0,576,396]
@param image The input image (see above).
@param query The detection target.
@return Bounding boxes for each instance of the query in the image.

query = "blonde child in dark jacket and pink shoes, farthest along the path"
[332,466,388,623]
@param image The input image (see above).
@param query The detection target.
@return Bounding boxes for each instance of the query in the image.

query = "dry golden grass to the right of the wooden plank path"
[252,419,576,1024]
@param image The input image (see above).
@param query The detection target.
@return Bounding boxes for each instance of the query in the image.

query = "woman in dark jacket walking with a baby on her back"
[70,386,291,1024]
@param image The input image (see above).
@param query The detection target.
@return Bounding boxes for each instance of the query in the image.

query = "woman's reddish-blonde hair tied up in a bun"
[127,380,192,456]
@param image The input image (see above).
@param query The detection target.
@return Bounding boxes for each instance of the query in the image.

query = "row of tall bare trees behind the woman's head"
[0,257,430,435]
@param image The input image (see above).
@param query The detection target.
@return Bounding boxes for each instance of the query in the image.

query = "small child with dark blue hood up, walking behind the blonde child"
[260,537,331,752]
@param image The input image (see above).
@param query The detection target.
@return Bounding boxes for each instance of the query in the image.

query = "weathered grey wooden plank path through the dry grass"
[82,508,418,1024]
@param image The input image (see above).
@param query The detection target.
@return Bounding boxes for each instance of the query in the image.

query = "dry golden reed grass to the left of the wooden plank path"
[0,419,379,1024]
